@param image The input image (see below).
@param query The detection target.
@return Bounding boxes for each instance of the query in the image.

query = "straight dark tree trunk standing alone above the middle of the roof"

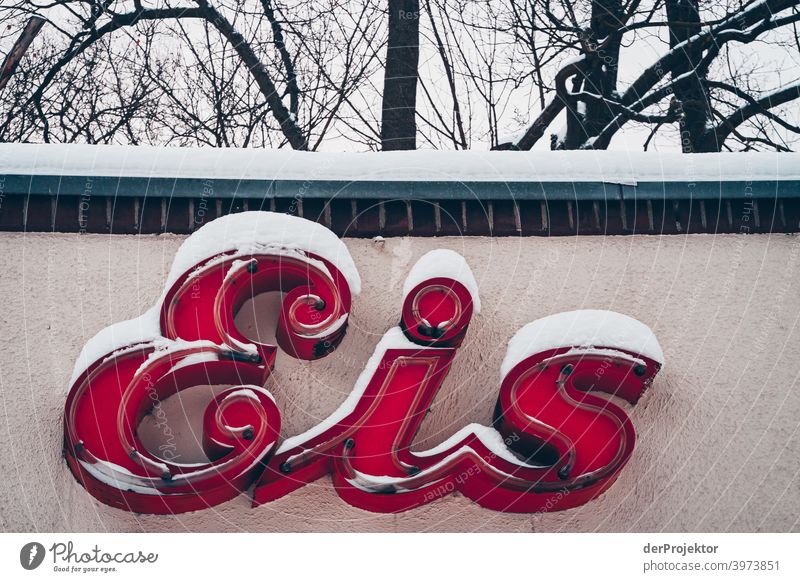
[381,0,419,151]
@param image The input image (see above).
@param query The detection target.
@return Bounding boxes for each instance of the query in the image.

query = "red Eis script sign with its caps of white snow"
[64,212,663,513]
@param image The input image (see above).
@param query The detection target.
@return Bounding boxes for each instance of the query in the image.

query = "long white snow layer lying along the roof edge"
[0,143,800,184]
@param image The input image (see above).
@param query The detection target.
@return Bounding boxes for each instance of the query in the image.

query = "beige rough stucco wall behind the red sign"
[0,233,800,531]
